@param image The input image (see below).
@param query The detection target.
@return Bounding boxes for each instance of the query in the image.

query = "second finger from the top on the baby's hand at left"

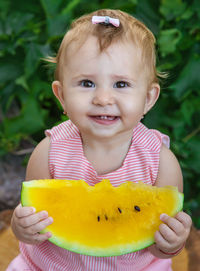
[19,211,48,228]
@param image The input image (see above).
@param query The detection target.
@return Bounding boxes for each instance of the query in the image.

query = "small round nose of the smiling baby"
[92,88,115,106]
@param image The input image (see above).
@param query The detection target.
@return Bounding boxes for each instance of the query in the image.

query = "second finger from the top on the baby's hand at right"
[160,214,184,236]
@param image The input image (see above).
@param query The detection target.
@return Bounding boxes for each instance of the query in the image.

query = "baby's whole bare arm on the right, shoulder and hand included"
[149,145,192,259]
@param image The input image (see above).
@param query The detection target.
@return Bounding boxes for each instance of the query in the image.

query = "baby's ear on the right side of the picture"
[144,83,160,115]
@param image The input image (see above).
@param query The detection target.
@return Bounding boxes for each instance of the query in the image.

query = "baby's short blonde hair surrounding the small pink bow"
[46,9,165,83]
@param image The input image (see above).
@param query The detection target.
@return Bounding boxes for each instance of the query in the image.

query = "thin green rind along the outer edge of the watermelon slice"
[21,181,184,257]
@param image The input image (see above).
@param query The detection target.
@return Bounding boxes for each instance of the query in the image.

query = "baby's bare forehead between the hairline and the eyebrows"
[65,36,142,78]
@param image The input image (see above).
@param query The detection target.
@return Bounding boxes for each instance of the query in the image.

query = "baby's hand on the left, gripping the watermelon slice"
[11,204,53,244]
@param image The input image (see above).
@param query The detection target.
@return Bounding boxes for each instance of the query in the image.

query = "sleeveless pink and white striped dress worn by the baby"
[7,121,172,271]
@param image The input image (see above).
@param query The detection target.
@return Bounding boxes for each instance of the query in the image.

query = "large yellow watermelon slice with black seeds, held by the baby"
[21,179,184,256]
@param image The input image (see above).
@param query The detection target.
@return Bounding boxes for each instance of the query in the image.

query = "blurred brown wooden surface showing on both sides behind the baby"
[0,210,200,271]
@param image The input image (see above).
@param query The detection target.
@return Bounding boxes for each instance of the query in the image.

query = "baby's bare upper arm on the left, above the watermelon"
[26,137,51,180]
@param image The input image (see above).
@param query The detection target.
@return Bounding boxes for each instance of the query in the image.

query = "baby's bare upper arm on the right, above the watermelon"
[155,144,183,192]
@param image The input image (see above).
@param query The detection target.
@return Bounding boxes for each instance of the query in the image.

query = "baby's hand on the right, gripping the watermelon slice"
[155,212,192,253]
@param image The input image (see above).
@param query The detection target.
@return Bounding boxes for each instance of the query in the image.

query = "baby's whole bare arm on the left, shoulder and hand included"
[11,138,53,244]
